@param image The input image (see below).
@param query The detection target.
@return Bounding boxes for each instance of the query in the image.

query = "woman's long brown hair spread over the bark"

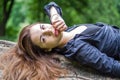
[0,24,66,80]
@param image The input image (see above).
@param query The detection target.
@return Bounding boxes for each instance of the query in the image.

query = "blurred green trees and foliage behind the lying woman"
[0,0,120,41]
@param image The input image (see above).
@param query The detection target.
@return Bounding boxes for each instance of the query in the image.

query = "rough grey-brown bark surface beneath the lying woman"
[0,40,119,80]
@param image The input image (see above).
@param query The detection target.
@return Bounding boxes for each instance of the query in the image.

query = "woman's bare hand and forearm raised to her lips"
[50,7,67,32]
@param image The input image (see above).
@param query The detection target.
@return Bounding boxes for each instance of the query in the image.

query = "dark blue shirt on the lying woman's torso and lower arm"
[56,23,120,77]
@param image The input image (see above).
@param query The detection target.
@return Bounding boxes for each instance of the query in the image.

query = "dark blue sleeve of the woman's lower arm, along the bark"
[69,41,120,77]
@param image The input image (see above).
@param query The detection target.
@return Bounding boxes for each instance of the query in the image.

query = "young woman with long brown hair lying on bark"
[1,2,120,80]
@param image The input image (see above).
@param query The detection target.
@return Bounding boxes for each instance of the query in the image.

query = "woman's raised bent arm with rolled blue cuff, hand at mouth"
[44,2,67,32]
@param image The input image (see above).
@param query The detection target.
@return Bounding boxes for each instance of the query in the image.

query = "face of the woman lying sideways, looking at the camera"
[30,23,62,50]
